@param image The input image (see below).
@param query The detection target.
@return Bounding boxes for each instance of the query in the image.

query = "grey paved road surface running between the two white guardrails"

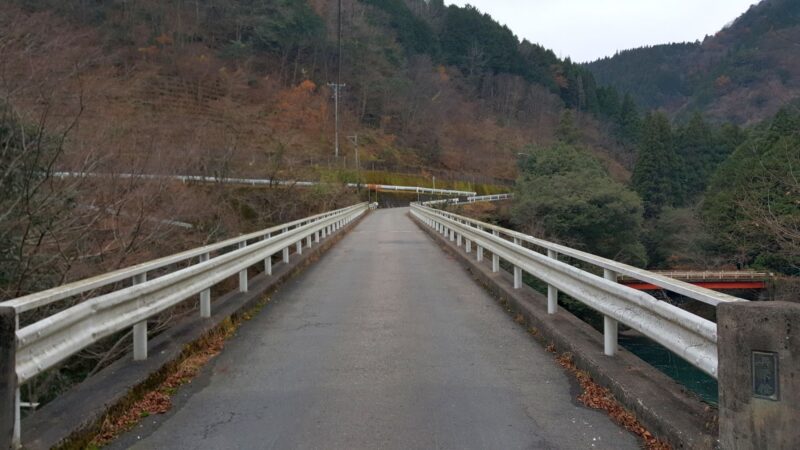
[114,209,638,449]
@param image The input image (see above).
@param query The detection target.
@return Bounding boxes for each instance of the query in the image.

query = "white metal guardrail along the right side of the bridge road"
[411,203,745,378]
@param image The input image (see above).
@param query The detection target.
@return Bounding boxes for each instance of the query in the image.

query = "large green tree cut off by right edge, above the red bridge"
[703,110,800,276]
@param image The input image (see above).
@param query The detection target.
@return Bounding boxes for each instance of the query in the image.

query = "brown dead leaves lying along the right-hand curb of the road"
[556,353,672,450]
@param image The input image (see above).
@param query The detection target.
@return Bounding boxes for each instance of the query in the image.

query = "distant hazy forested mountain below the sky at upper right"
[586,0,800,124]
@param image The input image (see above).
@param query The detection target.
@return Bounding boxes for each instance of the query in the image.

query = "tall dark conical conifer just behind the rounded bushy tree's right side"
[632,113,682,218]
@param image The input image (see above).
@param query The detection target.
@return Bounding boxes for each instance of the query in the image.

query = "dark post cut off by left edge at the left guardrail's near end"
[0,306,20,449]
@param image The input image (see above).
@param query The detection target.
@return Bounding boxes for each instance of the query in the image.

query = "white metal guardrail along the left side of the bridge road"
[0,203,369,444]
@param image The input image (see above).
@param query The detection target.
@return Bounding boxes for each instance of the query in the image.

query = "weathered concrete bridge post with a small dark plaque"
[717,302,800,450]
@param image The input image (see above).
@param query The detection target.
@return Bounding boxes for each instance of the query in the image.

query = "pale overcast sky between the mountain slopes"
[445,0,758,62]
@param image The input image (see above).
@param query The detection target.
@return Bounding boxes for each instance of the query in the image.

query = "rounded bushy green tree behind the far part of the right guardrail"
[511,143,647,265]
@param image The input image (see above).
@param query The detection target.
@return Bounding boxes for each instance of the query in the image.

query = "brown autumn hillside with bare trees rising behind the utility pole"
[0,0,631,185]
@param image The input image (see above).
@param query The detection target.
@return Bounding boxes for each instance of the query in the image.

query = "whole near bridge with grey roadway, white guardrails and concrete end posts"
[0,201,800,449]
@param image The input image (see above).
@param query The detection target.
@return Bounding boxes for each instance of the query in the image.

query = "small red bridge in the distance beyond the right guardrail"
[619,271,774,291]
